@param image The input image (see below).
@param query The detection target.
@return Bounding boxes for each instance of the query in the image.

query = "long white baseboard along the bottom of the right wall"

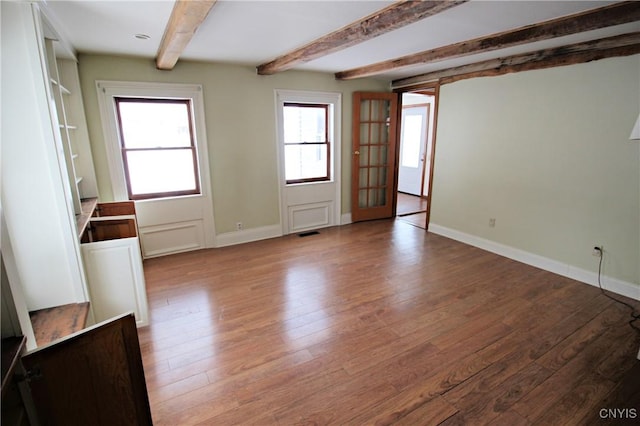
[429,223,640,300]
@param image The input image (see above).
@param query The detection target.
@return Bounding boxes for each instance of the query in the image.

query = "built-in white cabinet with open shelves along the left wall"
[0,2,147,350]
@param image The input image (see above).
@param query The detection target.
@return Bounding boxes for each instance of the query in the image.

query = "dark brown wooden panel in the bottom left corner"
[22,314,152,426]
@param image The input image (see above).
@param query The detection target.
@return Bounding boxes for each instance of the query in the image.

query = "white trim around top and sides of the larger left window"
[96,80,211,205]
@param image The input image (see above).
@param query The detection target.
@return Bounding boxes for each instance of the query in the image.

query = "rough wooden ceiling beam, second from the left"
[257,0,468,75]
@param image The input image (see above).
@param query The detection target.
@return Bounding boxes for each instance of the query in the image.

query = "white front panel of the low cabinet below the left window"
[80,238,148,326]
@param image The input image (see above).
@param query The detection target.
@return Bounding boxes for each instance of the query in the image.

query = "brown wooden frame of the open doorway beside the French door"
[393,81,440,232]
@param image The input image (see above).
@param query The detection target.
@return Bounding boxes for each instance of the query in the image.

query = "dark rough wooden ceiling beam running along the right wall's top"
[391,32,640,89]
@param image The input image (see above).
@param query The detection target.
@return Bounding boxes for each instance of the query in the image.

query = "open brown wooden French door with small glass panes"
[351,92,398,222]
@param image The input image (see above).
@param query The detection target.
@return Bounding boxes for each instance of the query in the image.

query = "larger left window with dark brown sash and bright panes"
[114,97,200,200]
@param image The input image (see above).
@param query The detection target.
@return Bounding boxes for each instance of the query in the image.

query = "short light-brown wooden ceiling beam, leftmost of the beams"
[156,0,217,70]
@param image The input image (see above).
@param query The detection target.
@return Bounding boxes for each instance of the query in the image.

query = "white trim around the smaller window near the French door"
[274,89,342,234]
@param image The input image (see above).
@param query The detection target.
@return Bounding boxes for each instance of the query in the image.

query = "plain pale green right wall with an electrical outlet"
[431,55,640,299]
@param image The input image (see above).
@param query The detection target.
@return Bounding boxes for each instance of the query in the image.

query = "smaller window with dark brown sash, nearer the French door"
[283,102,331,184]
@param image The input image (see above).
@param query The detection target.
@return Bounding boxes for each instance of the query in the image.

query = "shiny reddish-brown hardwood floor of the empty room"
[139,220,640,425]
